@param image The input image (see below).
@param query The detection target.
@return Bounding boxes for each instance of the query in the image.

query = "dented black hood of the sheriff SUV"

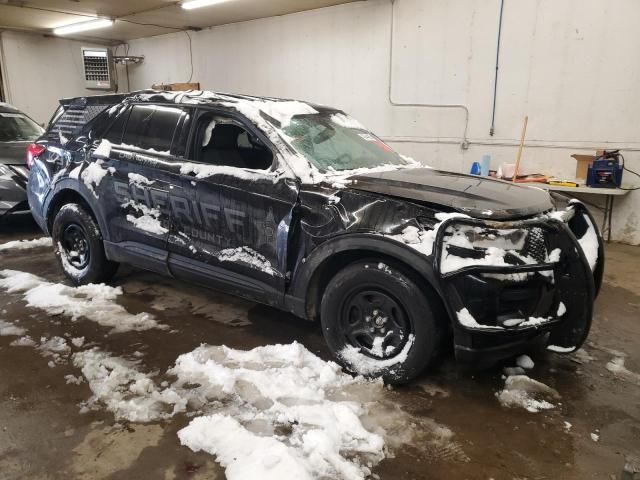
[349,168,553,220]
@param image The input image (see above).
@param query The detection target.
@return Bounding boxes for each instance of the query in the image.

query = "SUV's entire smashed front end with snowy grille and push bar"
[433,201,604,366]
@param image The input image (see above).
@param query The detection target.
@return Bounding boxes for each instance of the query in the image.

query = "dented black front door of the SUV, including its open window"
[169,111,298,303]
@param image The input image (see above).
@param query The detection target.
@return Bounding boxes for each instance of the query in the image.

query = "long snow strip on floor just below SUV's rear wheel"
[0,270,167,333]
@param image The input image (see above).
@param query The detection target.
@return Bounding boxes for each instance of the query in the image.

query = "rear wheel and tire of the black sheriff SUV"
[51,203,118,285]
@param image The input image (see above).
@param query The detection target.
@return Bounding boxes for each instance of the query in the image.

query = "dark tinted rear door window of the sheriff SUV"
[122,105,183,153]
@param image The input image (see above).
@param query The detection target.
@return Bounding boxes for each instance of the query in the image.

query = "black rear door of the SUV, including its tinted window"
[94,104,190,273]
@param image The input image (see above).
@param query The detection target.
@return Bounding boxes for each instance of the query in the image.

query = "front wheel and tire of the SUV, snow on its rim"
[320,260,446,384]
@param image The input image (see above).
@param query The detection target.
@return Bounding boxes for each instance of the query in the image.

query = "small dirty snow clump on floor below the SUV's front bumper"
[496,375,560,413]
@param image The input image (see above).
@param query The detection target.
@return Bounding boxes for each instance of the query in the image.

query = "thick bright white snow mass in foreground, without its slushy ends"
[170,343,384,479]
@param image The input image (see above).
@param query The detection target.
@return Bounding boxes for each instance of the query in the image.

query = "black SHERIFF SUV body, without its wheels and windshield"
[29,91,604,364]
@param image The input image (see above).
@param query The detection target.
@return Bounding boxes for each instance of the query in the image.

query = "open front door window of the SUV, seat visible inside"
[192,114,273,170]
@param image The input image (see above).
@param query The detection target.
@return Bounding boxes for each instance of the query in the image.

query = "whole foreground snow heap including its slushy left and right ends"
[73,343,448,480]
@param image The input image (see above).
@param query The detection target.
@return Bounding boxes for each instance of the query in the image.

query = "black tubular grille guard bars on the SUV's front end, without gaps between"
[432,201,604,356]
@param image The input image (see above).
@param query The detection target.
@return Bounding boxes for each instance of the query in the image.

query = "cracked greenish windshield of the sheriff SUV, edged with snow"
[283,112,409,171]
